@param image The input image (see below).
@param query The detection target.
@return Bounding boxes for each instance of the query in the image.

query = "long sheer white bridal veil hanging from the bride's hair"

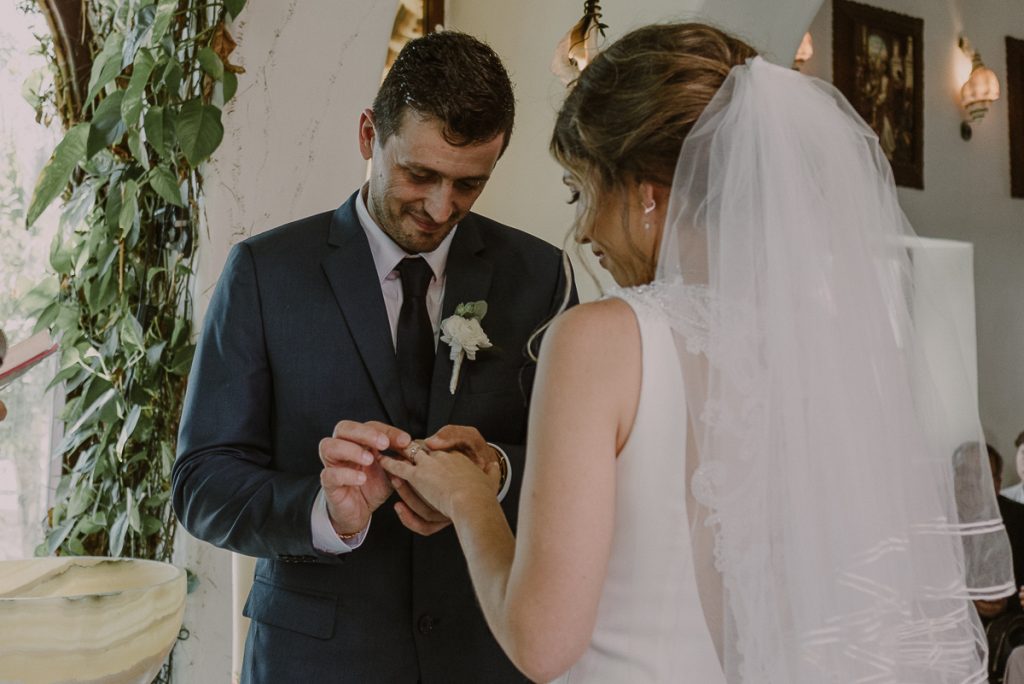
[653,57,1014,684]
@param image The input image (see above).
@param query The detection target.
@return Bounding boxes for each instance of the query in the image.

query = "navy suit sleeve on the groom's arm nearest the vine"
[172,244,326,560]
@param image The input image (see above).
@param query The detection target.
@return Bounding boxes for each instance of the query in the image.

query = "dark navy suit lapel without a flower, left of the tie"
[321,195,408,425]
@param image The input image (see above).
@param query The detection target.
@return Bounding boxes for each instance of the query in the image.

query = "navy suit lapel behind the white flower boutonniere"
[427,214,493,434]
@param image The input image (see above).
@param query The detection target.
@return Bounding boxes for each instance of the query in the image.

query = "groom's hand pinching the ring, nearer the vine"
[319,421,412,537]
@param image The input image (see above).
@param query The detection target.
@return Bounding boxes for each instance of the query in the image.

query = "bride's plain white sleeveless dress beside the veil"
[556,290,725,684]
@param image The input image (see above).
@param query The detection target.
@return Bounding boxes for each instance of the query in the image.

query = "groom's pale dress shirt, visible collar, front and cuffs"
[311,185,512,554]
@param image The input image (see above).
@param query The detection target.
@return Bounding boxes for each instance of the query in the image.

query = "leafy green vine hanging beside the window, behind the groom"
[26,0,245,560]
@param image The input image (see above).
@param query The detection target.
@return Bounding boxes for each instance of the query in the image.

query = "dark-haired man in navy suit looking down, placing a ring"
[173,32,574,684]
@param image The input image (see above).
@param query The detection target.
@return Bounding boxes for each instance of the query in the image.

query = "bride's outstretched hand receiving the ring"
[381,442,498,522]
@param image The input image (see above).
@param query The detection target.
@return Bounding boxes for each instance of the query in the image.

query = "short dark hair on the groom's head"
[374,31,515,152]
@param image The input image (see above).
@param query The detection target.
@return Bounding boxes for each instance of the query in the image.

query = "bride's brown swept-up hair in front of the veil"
[551,24,757,282]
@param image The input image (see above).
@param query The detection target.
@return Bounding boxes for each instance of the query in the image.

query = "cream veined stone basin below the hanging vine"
[0,557,185,684]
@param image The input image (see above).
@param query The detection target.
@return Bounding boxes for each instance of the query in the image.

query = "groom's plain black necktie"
[395,257,434,439]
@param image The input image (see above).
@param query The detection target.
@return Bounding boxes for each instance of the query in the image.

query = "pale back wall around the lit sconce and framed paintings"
[804,0,1024,484]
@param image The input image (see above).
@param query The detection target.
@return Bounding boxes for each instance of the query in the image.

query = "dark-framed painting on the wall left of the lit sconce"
[833,0,925,188]
